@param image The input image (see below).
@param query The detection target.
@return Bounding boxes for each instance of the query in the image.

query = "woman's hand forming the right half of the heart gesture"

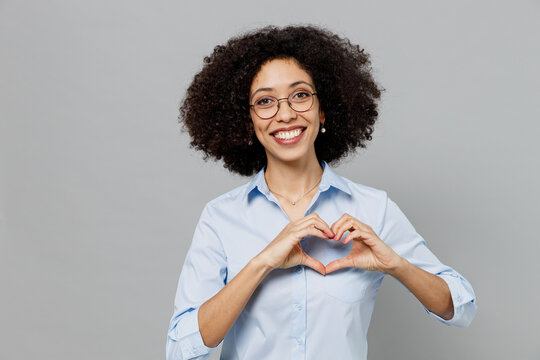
[326,214,403,274]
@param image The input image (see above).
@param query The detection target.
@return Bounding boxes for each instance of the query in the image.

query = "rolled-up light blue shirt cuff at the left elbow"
[166,307,217,360]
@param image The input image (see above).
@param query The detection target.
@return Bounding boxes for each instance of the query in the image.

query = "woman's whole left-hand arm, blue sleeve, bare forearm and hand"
[166,205,330,360]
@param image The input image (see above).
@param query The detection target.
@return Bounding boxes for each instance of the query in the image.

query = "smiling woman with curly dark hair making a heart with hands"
[166,26,476,359]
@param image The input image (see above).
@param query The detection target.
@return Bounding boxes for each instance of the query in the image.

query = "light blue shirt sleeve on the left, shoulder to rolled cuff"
[165,204,227,360]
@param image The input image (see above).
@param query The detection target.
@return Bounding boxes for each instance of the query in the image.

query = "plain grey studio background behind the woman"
[0,0,540,360]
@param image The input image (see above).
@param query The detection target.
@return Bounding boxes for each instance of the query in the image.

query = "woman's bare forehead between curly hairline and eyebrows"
[250,59,313,93]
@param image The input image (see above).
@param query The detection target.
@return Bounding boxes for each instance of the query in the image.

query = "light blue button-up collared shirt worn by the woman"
[166,161,476,360]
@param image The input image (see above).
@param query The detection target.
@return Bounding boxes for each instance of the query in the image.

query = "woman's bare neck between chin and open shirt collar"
[264,154,323,199]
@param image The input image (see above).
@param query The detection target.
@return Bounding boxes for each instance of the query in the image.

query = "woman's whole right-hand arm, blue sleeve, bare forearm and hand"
[326,196,476,327]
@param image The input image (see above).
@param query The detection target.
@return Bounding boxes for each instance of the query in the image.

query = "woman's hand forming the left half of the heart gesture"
[258,213,335,275]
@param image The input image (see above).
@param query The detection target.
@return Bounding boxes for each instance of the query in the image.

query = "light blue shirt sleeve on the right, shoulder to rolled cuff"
[379,196,477,327]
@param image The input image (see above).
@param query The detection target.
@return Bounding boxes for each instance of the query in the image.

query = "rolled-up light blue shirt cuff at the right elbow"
[424,273,477,328]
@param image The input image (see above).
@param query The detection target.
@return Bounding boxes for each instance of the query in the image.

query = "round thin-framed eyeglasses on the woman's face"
[249,90,317,119]
